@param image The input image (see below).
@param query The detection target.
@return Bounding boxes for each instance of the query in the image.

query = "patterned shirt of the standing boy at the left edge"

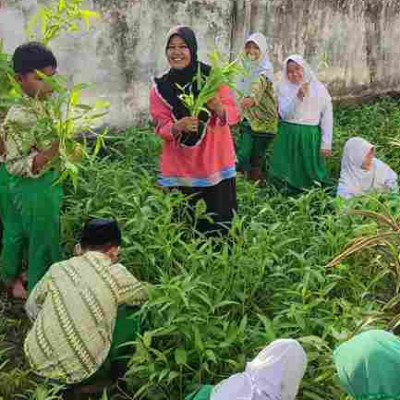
[0,106,50,178]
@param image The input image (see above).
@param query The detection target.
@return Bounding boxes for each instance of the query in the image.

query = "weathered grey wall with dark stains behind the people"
[0,0,400,126]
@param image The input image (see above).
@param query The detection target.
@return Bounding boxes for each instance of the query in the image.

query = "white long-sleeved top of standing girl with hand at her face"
[278,81,333,150]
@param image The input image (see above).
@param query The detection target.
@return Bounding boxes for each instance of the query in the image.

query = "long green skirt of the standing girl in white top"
[270,121,332,191]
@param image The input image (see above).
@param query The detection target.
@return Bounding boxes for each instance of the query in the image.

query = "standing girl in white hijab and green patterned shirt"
[237,33,278,181]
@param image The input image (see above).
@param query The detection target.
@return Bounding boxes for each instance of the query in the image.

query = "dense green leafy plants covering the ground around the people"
[0,99,400,400]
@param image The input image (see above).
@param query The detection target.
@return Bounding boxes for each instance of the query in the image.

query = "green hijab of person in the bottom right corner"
[334,330,400,400]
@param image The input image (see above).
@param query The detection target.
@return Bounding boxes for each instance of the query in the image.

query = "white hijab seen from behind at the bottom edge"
[211,339,307,400]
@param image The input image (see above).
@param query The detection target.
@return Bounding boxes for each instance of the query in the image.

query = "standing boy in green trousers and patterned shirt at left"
[0,42,63,299]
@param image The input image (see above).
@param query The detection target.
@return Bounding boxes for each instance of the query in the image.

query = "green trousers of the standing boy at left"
[0,164,63,292]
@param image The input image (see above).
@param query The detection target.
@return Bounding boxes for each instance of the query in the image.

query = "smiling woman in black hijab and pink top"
[150,26,239,234]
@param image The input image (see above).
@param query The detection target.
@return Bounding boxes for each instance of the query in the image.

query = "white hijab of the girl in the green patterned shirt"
[238,32,274,96]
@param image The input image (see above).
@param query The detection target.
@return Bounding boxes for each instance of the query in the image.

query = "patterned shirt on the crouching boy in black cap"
[24,252,147,384]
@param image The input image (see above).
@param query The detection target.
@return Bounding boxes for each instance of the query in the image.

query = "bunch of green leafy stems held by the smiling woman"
[178,52,242,117]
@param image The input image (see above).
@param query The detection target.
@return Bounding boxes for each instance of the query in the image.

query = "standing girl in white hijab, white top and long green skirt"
[271,55,333,192]
